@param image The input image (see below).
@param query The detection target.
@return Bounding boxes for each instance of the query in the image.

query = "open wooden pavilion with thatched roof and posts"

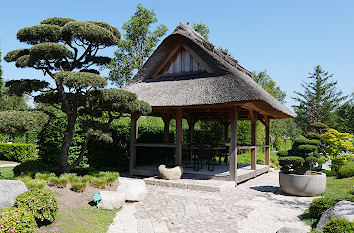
[125,24,294,184]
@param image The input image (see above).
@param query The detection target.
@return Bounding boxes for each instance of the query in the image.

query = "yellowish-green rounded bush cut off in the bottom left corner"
[0,207,37,233]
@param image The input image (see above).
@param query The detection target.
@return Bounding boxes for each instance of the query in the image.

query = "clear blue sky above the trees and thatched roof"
[0,0,354,110]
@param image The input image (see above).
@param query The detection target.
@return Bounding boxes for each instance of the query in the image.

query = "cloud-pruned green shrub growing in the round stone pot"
[277,136,321,175]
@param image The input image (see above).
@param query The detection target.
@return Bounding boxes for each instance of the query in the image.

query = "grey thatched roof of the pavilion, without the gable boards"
[125,24,294,118]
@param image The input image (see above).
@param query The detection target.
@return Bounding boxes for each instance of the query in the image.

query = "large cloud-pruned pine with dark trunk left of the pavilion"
[4,17,151,172]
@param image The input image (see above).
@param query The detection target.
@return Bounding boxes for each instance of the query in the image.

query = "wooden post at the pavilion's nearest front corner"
[229,107,238,184]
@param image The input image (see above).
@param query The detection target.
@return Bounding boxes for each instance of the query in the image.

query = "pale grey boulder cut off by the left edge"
[0,180,27,209]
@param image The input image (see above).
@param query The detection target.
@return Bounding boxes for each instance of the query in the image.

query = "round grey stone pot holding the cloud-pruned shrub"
[279,172,326,197]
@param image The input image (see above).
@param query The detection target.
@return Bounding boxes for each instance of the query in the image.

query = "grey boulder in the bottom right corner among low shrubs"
[316,201,354,231]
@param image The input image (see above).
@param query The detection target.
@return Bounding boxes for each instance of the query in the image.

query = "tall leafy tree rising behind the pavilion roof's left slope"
[107,3,167,87]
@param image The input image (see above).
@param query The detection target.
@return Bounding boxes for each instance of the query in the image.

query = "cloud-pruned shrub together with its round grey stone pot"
[278,136,326,196]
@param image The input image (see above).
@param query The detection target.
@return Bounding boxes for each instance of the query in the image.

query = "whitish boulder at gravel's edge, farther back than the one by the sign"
[117,179,147,201]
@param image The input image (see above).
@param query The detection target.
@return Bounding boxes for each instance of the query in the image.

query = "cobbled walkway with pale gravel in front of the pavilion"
[108,172,313,233]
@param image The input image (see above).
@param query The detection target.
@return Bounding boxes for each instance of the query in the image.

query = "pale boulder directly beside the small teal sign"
[97,191,125,210]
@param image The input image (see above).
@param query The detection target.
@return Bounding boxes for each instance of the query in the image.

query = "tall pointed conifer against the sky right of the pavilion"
[293,65,346,132]
